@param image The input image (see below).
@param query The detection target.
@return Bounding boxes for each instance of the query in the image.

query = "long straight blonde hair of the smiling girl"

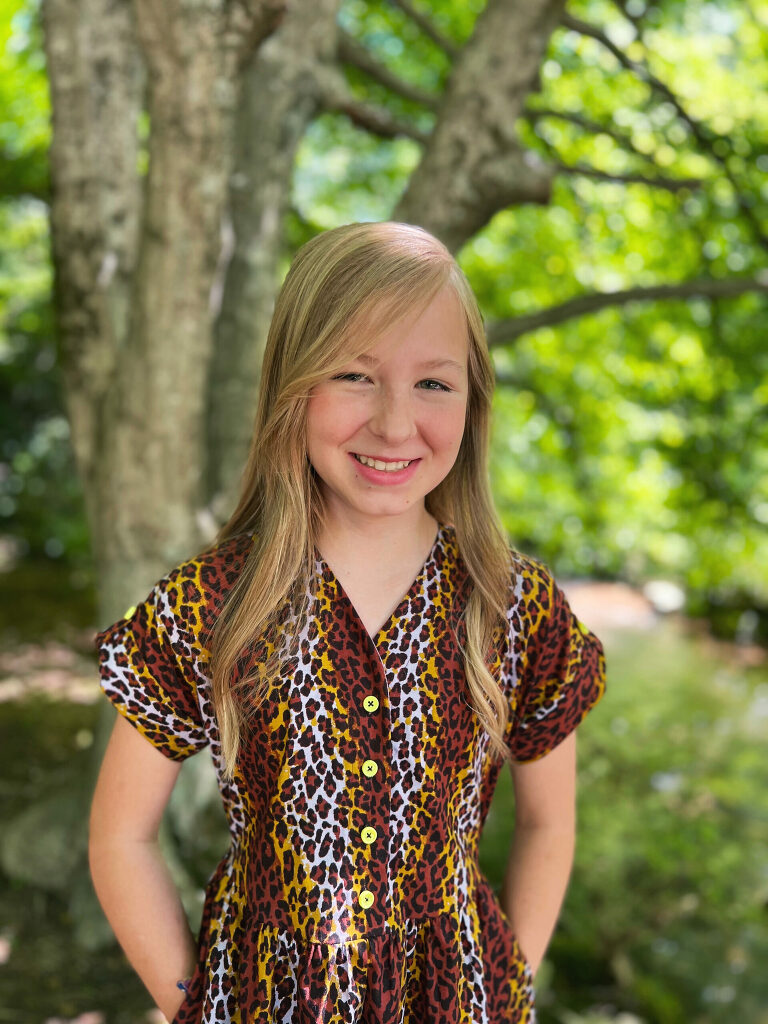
[207,222,518,777]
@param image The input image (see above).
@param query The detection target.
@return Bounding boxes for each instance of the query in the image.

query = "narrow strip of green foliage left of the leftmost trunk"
[0,0,88,564]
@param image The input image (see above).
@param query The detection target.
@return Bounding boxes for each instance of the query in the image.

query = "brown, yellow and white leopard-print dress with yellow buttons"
[96,523,605,1024]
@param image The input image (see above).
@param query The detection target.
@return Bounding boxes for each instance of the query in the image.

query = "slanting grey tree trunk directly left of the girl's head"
[207,0,340,522]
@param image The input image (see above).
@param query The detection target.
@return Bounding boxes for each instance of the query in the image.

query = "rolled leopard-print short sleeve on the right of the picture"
[508,563,605,762]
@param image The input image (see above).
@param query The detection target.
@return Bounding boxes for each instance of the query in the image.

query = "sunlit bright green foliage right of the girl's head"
[462,2,768,622]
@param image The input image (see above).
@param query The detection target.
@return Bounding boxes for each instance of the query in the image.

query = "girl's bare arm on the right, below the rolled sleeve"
[502,730,575,974]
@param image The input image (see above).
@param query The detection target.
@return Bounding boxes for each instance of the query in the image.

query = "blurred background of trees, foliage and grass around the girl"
[0,0,768,1024]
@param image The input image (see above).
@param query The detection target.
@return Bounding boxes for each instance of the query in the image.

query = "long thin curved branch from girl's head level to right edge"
[487,270,768,347]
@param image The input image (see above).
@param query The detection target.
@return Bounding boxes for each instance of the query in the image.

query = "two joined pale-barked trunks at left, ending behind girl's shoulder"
[43,0,282,621]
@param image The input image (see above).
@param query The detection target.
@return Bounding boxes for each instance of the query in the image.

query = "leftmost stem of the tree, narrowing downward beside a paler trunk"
[42,0,145,603]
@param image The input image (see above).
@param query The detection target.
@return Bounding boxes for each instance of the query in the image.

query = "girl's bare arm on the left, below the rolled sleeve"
[88,715,197,1021]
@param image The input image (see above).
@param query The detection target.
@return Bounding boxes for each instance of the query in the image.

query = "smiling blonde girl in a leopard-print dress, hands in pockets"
[90,223,605,1024]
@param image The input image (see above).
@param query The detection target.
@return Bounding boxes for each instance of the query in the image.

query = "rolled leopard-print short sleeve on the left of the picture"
[94,577,209,761]
